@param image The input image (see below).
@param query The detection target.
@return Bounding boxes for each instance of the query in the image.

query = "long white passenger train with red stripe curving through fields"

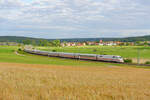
[24,49,124,63]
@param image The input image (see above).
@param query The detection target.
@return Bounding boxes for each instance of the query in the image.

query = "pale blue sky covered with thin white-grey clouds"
[0,0,150,38]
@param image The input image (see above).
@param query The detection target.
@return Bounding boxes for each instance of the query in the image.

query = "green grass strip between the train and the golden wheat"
[0,46,149,68]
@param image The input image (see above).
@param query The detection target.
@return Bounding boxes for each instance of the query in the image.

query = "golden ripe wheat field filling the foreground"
[0,63,150,100]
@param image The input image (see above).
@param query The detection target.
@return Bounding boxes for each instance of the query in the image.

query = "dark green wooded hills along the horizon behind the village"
[0,36,150,45]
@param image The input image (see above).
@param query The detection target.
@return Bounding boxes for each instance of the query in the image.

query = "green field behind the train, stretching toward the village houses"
[37,46,150,63]
